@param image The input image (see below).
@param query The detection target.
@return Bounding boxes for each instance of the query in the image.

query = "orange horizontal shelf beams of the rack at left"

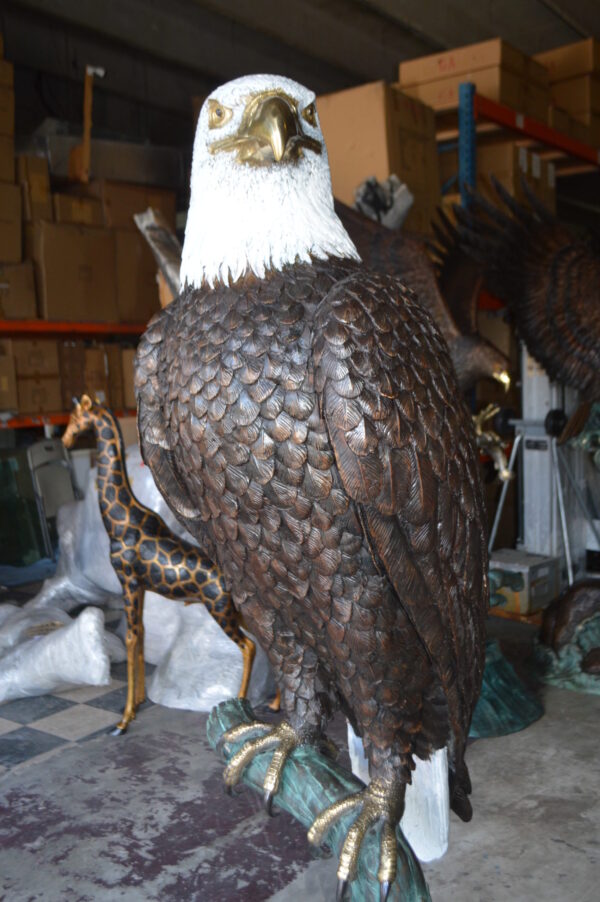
[0,319,146,429]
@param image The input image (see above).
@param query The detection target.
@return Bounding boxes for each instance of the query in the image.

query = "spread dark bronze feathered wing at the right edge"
[456,179,600,400]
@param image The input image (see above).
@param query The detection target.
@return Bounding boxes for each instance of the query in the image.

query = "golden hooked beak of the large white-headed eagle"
[208,92,322,166]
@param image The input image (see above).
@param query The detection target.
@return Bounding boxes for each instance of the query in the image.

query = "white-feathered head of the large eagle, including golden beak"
[181,75,360,287]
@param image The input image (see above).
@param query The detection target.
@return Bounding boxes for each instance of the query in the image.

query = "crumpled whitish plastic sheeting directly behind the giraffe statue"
[17,446,275,711]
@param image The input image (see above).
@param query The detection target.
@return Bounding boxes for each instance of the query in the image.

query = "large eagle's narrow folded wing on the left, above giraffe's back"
[135,307,200,528]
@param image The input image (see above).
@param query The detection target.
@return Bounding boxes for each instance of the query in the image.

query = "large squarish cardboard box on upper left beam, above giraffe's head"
[33,222,118,323]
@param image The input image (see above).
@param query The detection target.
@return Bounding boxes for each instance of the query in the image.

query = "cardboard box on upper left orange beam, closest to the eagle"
[115,229,160,323]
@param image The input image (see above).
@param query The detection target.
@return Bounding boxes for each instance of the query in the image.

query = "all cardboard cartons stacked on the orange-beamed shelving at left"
[0,34,176,415]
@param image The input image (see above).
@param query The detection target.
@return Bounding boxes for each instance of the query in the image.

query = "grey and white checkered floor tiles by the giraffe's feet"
[0,612,154,775]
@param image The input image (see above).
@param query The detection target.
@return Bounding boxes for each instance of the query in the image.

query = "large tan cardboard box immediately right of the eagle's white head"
[317,81,440,234]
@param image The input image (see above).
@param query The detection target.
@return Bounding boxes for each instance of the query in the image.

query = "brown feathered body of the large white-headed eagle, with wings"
[136,259,488,818]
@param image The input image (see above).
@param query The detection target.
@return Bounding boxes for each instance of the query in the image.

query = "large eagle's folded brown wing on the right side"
[314,271,488,760]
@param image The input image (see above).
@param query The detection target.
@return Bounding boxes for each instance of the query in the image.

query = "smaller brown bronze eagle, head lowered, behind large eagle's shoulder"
[335,200,510,392]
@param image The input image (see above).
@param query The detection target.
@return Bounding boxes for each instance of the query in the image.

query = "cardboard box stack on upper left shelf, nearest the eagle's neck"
[17,170,175,323]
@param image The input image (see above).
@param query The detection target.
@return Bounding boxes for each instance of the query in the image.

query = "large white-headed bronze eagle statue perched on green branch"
[135,75,488,898]
